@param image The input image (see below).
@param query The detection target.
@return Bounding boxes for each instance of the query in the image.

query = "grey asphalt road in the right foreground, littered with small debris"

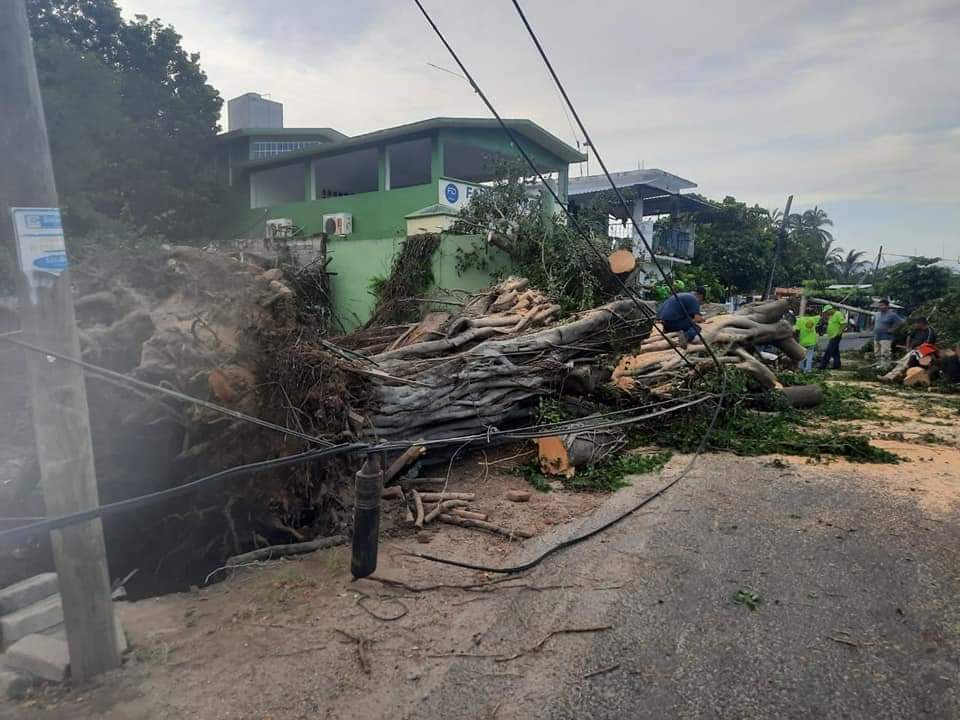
[402,456,960,720]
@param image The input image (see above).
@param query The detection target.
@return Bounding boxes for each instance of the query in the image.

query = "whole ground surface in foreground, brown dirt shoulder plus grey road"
[0,380,960,720]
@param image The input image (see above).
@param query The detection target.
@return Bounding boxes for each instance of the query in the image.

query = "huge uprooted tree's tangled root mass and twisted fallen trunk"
[15,245,808,591]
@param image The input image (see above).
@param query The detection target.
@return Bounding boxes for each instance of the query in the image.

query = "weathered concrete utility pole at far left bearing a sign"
[0,0,120,680]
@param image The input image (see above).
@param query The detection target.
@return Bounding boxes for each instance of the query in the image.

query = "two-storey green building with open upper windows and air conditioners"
[217,106,585,327]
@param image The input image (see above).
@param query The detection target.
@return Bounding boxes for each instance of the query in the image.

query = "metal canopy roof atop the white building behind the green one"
[567,168,714,220]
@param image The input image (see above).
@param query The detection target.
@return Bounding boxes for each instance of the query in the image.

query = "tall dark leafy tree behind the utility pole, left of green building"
[27,0,227,239]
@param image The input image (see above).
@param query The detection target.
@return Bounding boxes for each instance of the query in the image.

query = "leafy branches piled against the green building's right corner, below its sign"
[451,163,610,312]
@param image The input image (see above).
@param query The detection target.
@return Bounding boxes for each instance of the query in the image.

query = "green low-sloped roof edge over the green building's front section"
[236,117,587,170]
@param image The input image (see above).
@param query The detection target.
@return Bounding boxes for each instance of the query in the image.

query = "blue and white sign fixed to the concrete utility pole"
[10,208,67,302]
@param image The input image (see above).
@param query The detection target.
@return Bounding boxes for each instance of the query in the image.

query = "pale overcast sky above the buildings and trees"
[118,0,960,260]
